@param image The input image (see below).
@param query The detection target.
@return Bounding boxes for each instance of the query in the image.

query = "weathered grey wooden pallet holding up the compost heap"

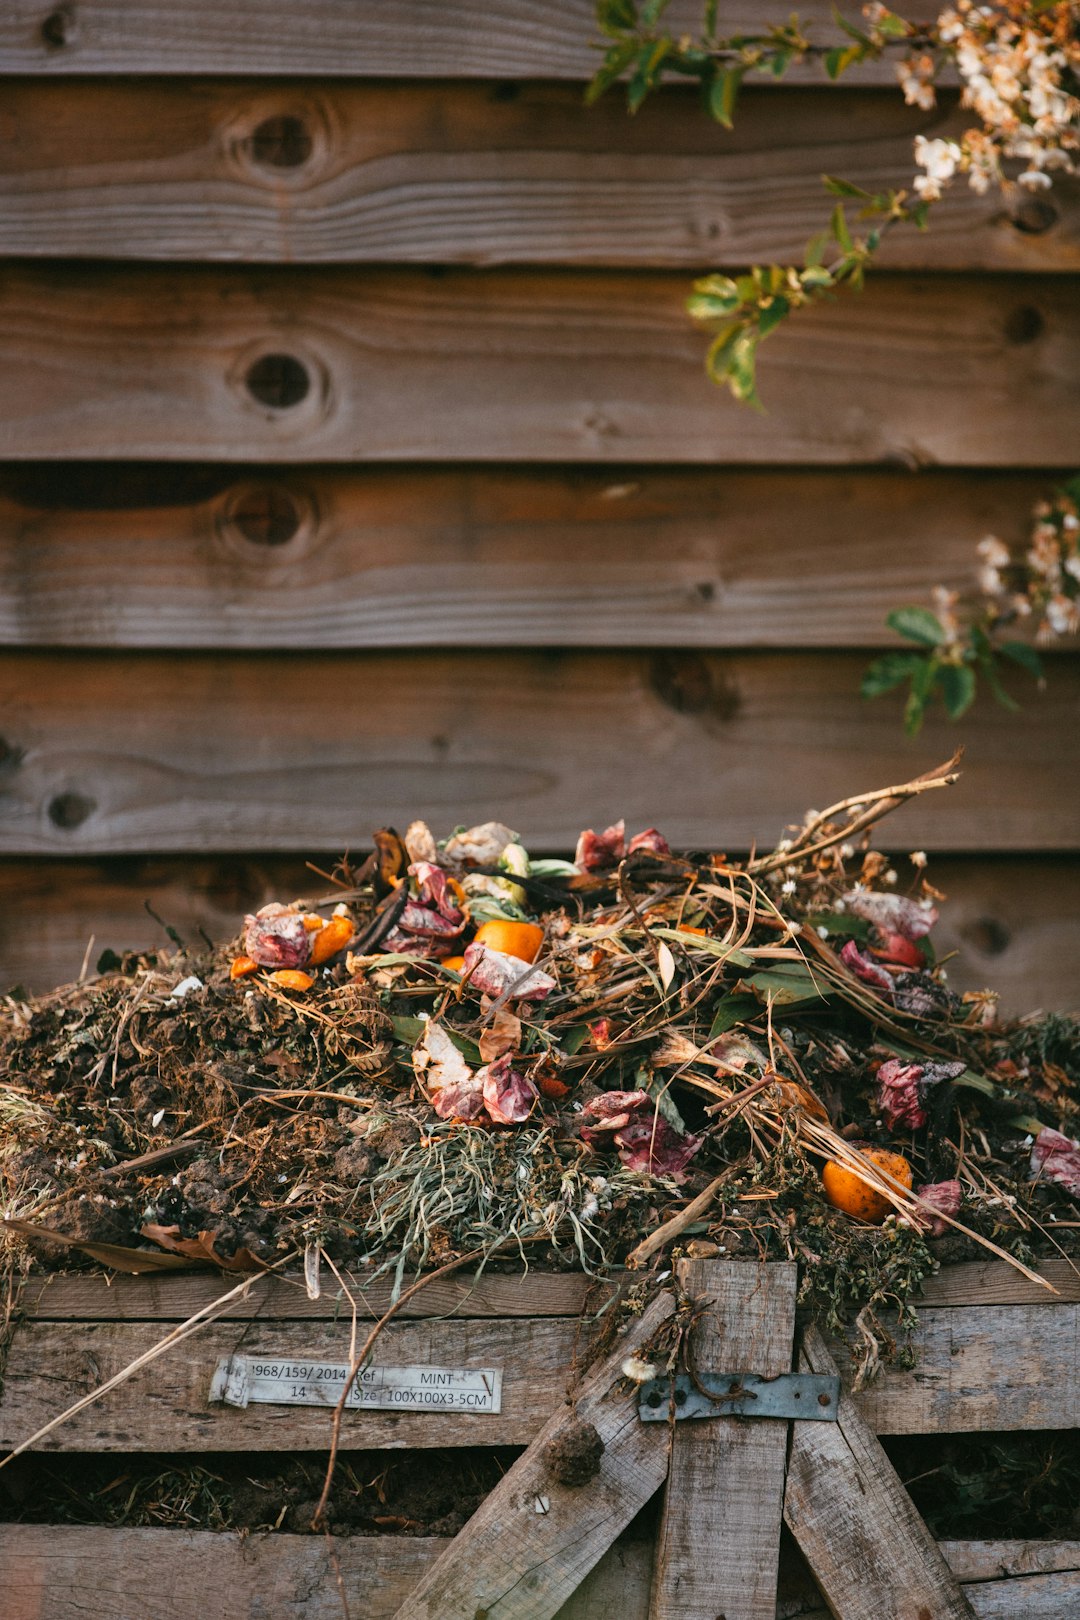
[0,1260,1080,1620]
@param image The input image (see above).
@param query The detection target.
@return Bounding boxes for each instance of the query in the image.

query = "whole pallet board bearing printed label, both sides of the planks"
[0,1304,1080,1452]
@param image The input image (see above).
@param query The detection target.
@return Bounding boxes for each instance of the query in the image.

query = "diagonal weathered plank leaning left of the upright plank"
[388,1294,674,1620]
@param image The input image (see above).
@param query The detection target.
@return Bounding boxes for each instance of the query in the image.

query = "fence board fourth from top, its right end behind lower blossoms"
[0,463,1075,651]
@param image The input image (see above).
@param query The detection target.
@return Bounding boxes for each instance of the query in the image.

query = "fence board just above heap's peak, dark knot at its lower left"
[0,653,1080,854]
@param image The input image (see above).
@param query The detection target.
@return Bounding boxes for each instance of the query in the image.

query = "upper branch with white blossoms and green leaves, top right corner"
[588,0,1080,408]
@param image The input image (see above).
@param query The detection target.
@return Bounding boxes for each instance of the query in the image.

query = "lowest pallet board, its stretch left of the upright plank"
[0,1524,651,1620]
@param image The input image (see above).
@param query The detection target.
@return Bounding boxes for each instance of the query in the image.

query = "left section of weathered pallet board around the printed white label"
[0,1317,588,1452]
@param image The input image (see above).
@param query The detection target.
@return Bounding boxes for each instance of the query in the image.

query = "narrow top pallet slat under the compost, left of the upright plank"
[18,1272,612,1322]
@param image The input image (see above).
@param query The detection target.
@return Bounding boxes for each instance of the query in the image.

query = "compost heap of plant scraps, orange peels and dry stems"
[0,761,1080,1358]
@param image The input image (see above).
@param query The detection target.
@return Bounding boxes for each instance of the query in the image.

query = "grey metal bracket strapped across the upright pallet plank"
[638,1372,840,1422]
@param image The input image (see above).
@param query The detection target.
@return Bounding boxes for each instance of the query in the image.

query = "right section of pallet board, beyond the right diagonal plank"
[834,1304,1080,1434]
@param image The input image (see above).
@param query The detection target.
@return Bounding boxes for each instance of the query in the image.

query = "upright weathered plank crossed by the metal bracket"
[651,1260,797,1620]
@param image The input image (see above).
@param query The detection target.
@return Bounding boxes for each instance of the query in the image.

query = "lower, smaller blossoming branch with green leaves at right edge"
[861,475,1080,735]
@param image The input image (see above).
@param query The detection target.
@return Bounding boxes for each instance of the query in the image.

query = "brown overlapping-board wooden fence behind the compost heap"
[0,0,1080,1008]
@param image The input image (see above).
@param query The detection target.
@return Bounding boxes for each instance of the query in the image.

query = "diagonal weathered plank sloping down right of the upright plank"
[784,1328,975,1620]
